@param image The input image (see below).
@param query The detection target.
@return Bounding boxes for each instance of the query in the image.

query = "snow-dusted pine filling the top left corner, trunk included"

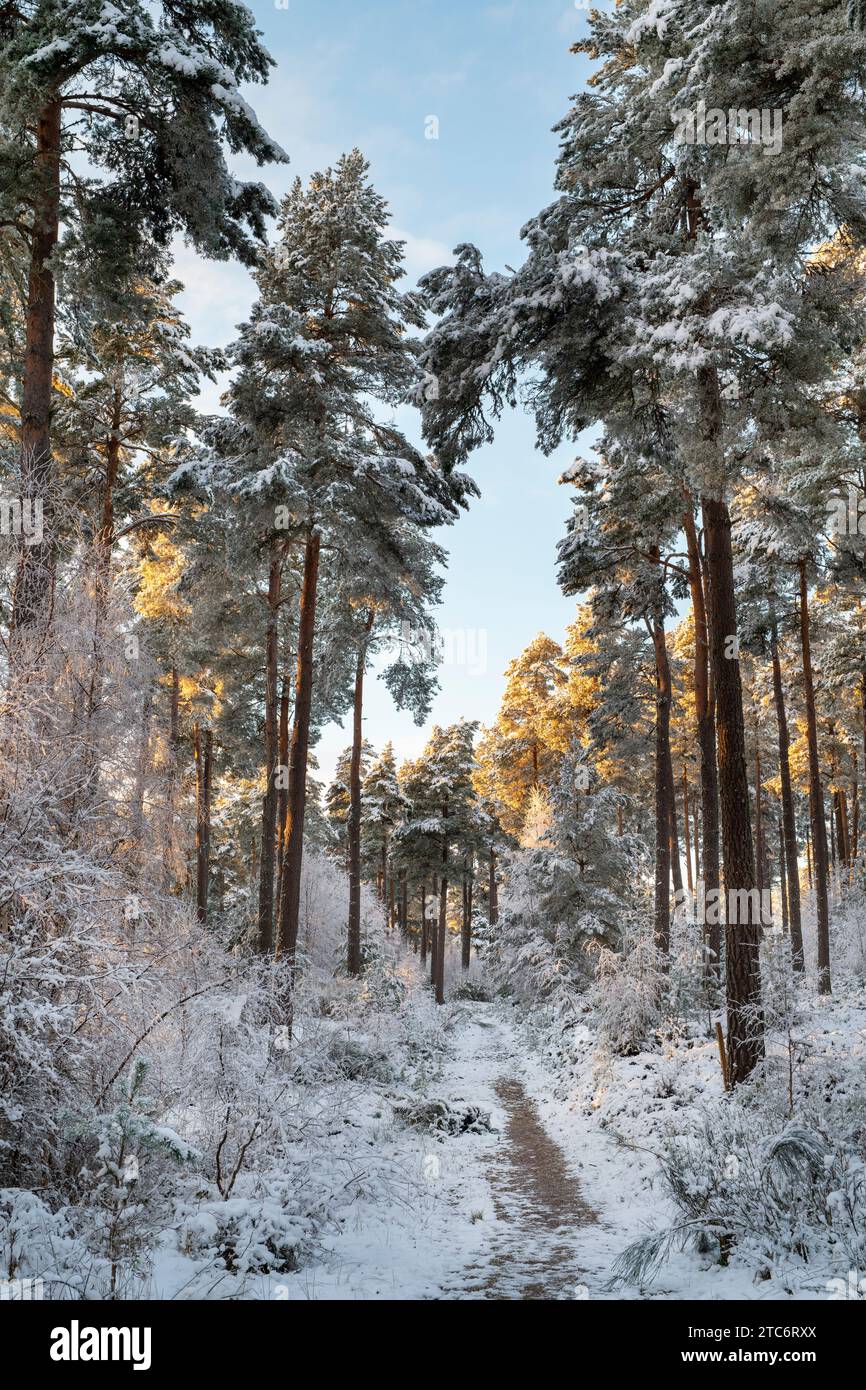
[0,0,285,631]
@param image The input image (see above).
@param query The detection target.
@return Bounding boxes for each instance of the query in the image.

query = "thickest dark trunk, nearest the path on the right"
[699,486,763,1086]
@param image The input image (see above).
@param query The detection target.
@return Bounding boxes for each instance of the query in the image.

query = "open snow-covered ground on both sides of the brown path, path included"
[234,967,866,1300]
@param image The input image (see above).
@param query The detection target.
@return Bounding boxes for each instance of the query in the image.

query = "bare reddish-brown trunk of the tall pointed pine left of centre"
[277,528,321,970]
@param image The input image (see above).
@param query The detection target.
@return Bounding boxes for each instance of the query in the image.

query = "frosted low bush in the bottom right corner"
[614,1059,866,1284]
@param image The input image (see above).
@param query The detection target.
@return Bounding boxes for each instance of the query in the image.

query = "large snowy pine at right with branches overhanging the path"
[423,0,866,1081]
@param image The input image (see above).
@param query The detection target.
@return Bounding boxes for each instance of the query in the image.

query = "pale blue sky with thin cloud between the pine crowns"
[177,0,603,776]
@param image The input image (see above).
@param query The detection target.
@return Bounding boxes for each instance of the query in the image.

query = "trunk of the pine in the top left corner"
[11,97,61,634]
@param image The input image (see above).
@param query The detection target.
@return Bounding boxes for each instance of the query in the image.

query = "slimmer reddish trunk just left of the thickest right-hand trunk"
[683,514,721,980]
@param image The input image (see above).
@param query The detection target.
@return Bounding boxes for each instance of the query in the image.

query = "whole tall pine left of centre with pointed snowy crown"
[195,150,473,978]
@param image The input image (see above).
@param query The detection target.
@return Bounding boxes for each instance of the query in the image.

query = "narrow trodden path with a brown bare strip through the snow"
[442,1005,598,1301]
